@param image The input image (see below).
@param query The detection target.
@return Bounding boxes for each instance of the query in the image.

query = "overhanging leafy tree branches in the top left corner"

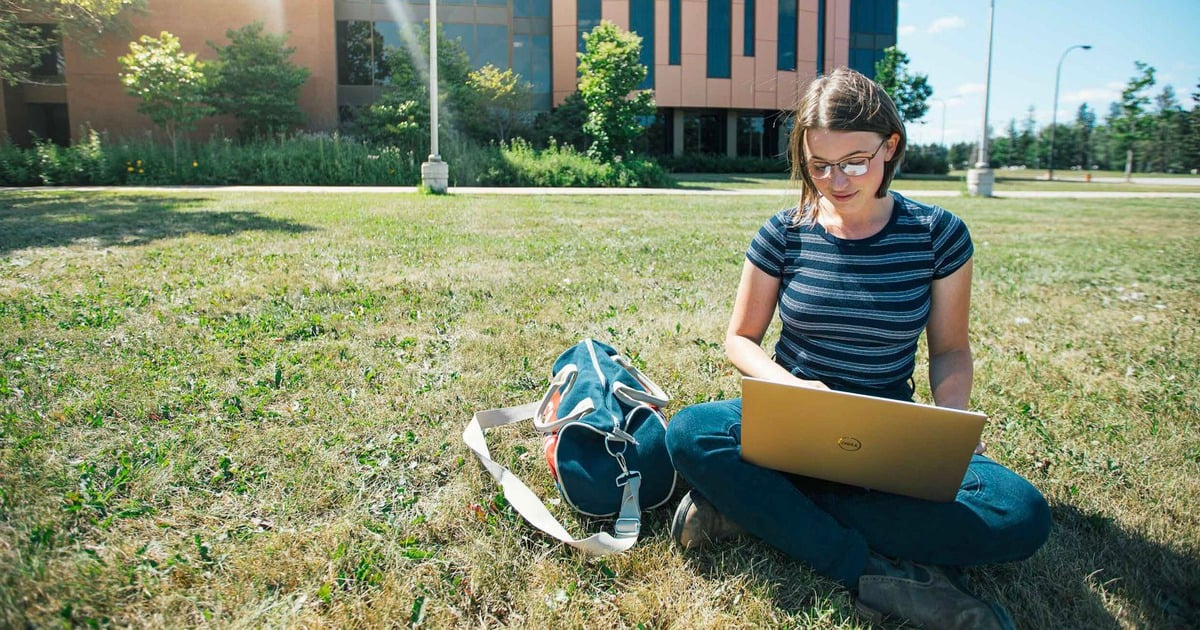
[0,0,145,83]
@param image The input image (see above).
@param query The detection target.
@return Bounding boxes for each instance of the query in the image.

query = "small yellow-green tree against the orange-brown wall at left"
[116,31,212,162]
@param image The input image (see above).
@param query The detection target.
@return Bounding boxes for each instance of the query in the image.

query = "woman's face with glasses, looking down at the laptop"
[804,128,900,212]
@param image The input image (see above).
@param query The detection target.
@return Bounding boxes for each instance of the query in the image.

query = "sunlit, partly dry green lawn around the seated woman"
[0,191,1200,628]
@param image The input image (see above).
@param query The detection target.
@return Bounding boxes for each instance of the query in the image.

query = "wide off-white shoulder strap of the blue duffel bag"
[462,398,642,556]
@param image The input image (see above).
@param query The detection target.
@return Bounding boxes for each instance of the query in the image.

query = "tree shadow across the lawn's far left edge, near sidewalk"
[0,192,316,256]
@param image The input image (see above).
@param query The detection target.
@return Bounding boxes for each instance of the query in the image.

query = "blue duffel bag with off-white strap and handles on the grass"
[463,340,677,554]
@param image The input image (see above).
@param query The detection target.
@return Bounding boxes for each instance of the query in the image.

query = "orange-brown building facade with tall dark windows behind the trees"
[0,0,896,157]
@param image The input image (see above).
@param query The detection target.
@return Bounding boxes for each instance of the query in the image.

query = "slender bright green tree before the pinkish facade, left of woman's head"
[578,20,654,160]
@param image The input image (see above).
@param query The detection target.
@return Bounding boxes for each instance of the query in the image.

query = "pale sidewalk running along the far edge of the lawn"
[9,186,1200,199]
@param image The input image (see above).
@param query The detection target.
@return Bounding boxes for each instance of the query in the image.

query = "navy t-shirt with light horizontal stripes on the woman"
[746,192,974,398]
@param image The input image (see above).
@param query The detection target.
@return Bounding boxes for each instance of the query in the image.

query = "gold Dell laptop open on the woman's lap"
[742,377,988,502]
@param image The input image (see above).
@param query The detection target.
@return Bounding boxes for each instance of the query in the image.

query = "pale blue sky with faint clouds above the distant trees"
[896,0,1200,144]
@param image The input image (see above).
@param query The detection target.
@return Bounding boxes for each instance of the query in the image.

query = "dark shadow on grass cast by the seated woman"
[667,496,1200,628]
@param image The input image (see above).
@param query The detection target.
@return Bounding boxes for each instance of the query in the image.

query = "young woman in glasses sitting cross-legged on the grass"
[667,68,1050,628]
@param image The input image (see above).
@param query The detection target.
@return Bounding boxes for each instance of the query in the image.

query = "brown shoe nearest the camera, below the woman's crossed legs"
[854,553,1014,630]
